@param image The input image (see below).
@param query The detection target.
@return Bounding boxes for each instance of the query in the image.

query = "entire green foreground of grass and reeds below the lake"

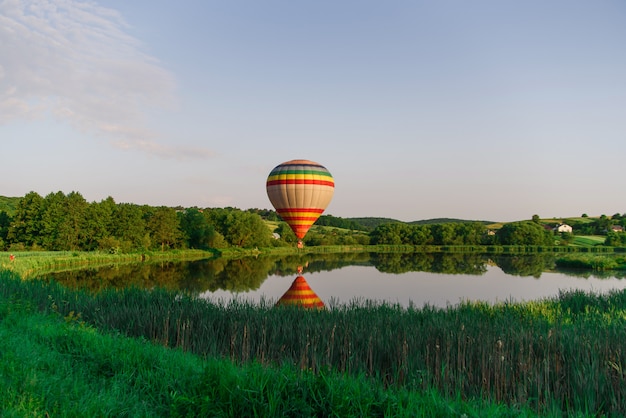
[0,264,626,416]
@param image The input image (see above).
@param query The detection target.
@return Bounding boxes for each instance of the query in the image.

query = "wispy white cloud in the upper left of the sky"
[0,0,210,158]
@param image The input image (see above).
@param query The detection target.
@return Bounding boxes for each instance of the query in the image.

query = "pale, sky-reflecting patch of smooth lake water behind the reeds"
[207,266,626,307]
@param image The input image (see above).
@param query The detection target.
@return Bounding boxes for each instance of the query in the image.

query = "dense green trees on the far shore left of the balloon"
[0,192,280,253]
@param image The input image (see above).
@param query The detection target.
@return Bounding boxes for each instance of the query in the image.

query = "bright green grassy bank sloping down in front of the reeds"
[0,272,535,417]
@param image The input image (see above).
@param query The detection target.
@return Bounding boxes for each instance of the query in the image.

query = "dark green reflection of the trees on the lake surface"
[48,253,615,293]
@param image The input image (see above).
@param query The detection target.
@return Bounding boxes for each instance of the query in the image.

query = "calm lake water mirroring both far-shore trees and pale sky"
[47,253,626,307]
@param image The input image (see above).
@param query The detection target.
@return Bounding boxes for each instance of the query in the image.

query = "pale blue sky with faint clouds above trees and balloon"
[0,0,626,222]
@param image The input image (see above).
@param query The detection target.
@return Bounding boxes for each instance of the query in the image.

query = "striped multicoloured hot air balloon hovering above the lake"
[266,160,335,247]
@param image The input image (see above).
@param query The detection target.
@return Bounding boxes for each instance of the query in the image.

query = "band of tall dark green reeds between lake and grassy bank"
[0,270,626,416]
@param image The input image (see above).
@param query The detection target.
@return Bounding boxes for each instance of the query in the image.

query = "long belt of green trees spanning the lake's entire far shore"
[0,192,626,253]
